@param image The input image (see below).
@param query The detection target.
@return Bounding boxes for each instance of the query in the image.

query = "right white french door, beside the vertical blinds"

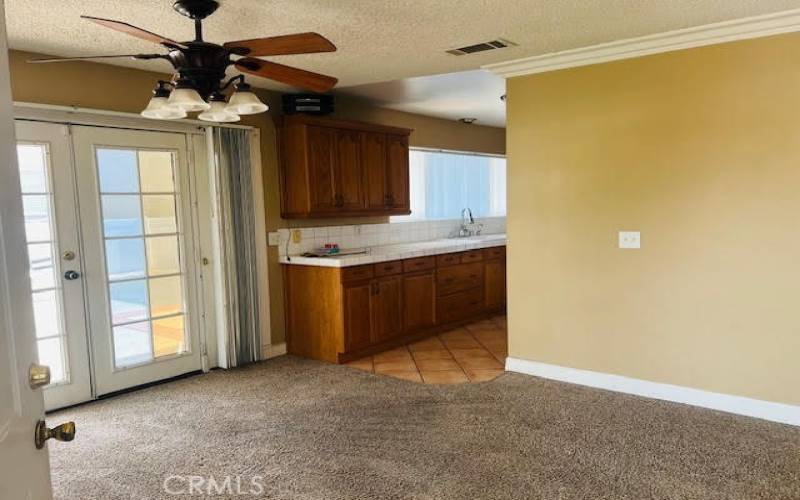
[73,127,201,395]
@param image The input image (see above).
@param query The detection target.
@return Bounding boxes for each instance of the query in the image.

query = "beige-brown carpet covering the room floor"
[48,356,800,500]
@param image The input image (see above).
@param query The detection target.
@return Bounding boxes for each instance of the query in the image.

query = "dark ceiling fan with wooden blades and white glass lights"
[28,0,338,122]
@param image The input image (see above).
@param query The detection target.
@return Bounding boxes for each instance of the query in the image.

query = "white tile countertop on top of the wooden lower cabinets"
[280,234,506,267]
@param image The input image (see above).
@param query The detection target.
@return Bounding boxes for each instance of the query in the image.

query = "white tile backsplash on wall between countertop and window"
[278,217,506,256]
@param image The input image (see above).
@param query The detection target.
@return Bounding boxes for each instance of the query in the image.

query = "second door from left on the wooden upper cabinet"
[334,130,364,210]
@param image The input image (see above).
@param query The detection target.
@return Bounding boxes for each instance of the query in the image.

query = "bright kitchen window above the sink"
[391,149,506,222]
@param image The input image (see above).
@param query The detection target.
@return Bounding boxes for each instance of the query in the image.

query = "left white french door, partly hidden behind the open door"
[16,121,92,409]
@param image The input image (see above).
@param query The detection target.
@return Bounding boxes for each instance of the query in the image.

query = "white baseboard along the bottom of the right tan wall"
[506,358,800,426]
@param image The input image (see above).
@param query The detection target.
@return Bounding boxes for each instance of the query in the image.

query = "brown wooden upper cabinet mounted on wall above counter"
[278,115,411,218]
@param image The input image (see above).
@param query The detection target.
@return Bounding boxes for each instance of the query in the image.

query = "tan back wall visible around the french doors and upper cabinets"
[10,51,505,344]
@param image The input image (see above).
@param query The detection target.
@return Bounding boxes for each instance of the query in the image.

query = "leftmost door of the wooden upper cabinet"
[306,127,337,212]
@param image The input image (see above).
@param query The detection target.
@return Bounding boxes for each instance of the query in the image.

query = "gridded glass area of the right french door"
[95,147,189,368]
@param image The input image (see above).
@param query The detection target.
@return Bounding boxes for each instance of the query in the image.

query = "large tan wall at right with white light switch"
[508,34,800,404]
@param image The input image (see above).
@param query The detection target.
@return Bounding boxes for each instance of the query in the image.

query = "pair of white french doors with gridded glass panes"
[17,121,201,409]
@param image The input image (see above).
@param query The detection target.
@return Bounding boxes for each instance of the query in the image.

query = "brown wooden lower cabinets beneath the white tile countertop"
[284,247,505,363]
